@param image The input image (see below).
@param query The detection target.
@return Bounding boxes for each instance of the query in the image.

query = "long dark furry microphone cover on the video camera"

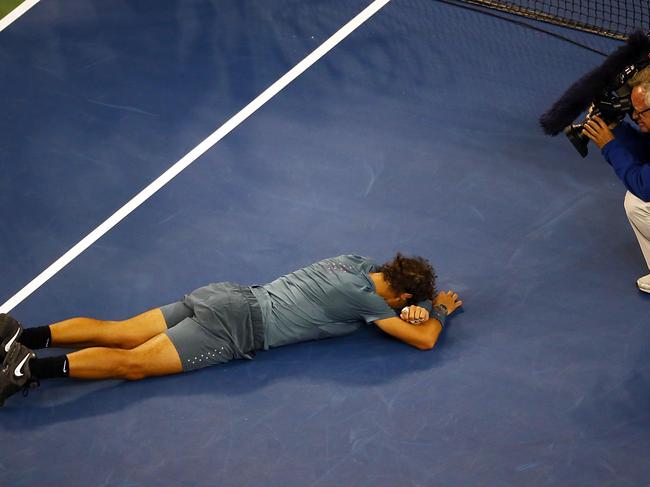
[539,31,650,135]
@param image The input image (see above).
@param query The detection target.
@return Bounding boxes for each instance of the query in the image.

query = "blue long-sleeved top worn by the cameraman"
[602,122,650,201]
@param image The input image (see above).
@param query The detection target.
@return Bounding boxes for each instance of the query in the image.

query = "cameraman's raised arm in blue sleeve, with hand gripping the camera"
[584,117,650,201]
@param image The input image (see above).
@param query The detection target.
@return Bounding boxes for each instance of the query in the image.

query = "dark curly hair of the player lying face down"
[379,252,436,304]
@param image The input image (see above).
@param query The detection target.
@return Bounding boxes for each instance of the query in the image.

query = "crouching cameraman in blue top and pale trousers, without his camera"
[582,80,650,293]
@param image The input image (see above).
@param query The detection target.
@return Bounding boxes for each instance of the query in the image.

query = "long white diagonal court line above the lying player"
[0,0,390,313]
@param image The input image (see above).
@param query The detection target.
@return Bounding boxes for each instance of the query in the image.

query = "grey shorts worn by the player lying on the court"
[160,282,264,372]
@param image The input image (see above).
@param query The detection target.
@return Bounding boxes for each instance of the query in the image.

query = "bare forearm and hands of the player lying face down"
[375,291,463,350]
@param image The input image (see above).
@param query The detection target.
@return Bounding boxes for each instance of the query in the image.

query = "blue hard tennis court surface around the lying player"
[0,0,650,487]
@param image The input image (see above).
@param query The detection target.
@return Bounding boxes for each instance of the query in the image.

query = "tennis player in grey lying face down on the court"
[0,253,462,406]
